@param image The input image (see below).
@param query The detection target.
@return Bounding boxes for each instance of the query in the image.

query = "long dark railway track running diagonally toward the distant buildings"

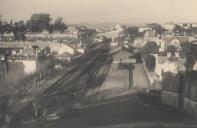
[44,44,105,98]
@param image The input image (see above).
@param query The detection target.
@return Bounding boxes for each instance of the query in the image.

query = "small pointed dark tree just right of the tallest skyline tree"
[53,17,67,32]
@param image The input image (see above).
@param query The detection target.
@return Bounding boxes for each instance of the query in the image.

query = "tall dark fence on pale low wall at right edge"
[161,72,197,116]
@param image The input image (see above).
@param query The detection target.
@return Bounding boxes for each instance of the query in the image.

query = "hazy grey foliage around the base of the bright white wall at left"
[0,58,65,98]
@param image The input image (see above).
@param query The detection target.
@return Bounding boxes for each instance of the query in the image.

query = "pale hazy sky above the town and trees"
[0,0,197,24]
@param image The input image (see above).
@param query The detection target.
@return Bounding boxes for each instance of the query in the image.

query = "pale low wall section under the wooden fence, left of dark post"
[161,90,178,107]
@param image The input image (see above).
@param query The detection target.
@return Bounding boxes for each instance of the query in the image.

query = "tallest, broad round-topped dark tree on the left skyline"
[27,13,51,32]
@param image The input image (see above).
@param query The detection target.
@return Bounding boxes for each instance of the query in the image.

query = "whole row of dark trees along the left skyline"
[0,13,67,40]
